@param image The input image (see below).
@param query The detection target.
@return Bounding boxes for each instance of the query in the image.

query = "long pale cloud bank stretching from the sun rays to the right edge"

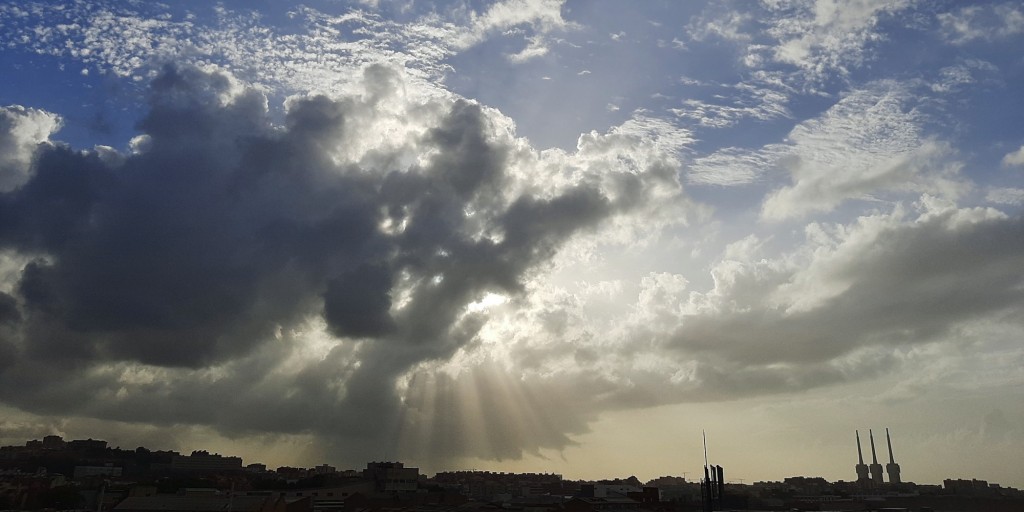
[395,196,1024,438]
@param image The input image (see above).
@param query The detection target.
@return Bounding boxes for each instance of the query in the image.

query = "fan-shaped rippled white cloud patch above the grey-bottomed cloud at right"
[762,82,967,220]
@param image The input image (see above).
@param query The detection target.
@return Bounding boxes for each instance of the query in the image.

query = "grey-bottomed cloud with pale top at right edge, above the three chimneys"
[668,198,1024,396]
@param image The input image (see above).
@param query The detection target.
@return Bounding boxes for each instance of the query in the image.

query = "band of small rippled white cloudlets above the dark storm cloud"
[0,0,574,95]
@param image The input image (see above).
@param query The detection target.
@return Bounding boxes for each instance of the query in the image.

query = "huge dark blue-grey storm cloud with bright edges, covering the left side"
[0,62,674,464]
